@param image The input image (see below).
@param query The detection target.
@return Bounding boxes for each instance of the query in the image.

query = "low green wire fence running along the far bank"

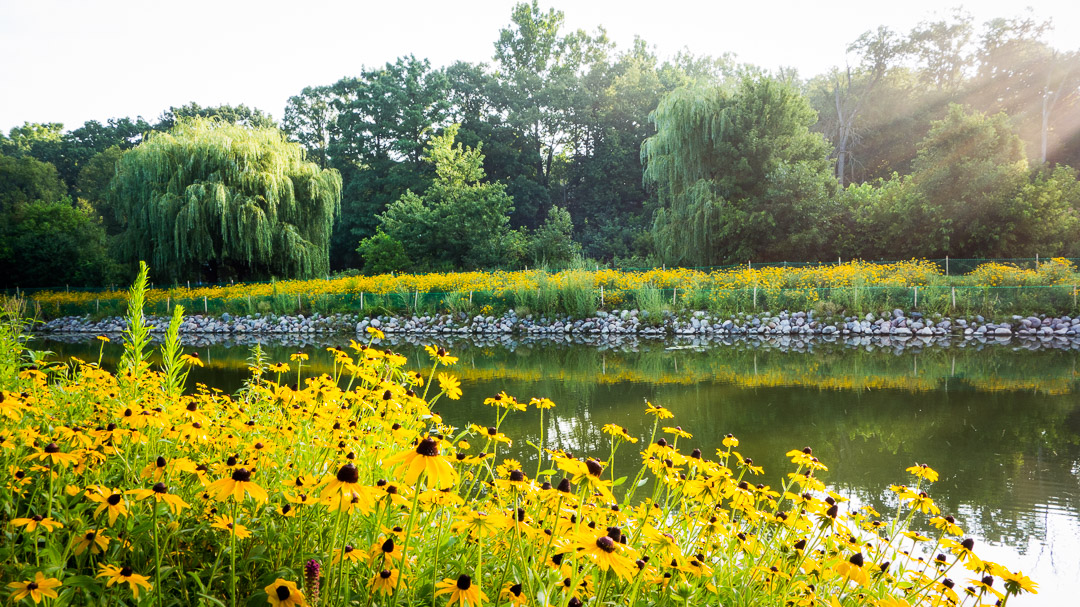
[28,285,1080,318]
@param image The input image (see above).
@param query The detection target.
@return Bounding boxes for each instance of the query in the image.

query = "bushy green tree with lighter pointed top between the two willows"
[379,125,513,268]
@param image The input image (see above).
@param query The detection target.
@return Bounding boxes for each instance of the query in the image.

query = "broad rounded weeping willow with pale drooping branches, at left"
[109,119,341,281]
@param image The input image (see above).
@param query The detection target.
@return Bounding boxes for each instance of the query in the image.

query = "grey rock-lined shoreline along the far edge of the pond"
[31,309,1080,349]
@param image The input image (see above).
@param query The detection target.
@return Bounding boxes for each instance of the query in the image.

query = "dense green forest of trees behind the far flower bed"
[0,1,1080,286]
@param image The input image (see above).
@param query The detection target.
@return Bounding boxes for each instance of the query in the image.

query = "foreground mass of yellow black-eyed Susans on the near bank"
[0,298,1036,607]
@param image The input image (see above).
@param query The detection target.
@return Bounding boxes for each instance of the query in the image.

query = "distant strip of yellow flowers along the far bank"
[27,258,1078,306]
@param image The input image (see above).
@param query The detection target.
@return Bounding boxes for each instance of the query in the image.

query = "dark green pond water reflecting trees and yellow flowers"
[32,337,1080,605]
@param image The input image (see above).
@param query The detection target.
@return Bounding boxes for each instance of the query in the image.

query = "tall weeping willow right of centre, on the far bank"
[642,77,835,266]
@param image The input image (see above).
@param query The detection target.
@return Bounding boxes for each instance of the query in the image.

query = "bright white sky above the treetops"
[0,0,1080,132]
